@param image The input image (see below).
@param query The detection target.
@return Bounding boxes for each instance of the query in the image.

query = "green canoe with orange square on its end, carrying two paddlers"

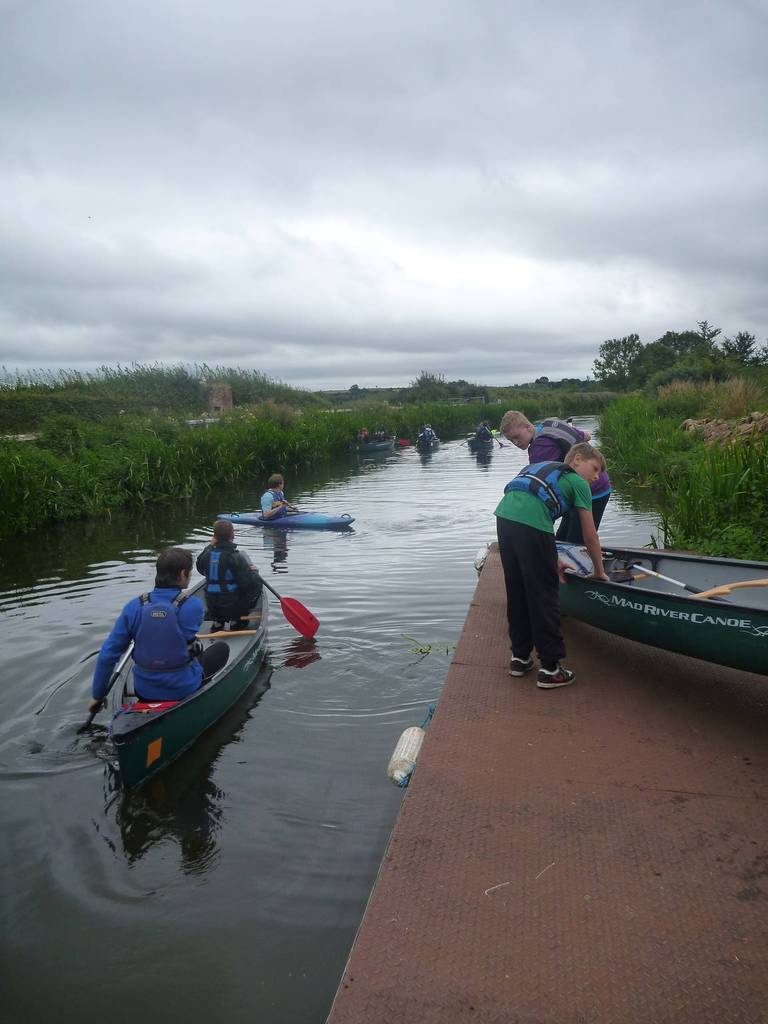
[110,580,268,790]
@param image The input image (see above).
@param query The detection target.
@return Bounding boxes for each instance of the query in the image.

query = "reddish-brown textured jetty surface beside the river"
[329,554,768,1024]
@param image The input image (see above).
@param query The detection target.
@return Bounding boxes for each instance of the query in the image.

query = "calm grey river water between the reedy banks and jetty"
[0,420,655,1024]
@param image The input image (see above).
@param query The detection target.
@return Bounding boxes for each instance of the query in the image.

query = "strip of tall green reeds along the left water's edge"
[0,404,493,537]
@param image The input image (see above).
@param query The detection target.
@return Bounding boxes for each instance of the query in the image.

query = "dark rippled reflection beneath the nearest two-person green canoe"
[108,671,270,874]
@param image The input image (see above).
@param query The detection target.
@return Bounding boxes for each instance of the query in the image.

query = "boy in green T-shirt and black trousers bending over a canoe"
[496,442,608,689]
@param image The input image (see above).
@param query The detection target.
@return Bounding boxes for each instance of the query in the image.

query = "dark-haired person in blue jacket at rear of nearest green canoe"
[88,548,229,712]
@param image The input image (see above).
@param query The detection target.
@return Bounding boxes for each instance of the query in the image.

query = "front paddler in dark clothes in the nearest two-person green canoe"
[195,519,261,633]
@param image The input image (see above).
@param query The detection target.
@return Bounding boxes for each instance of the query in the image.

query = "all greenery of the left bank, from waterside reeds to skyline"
[0,378,618,537]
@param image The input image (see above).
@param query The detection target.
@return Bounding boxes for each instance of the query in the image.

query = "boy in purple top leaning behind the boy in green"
[499,410,611,544]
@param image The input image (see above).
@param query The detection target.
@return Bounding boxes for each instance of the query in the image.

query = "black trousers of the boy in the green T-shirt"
[496,516,565,670]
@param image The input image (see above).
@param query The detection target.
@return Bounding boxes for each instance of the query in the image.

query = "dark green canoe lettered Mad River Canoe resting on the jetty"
[557,544,768,675]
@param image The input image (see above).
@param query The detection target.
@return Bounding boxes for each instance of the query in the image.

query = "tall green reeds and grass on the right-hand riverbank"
[600,385,768,560]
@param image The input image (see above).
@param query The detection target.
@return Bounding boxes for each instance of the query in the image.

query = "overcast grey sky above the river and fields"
[0,0,768,387]
